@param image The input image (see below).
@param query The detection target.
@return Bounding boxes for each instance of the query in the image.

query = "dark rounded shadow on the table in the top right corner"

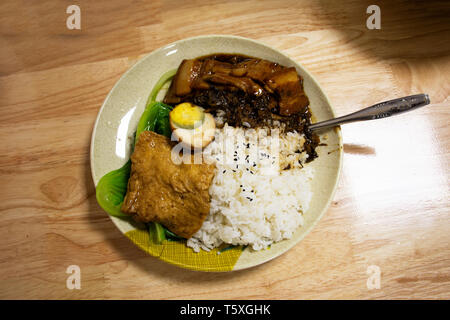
[318,0,450,59]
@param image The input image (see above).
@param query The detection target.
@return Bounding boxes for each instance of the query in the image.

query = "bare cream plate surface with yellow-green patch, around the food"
[90,35,342,271]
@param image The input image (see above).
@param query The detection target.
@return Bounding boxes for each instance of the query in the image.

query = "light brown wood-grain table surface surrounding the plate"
[0,0,450,299]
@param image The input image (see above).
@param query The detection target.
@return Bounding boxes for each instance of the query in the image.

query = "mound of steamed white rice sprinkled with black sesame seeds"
[187,124,313,252]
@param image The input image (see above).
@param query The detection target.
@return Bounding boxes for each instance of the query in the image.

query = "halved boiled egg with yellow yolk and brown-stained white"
[169,102,216,149]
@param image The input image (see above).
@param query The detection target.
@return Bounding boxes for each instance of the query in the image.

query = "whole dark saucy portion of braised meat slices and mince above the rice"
[164,54,320,161]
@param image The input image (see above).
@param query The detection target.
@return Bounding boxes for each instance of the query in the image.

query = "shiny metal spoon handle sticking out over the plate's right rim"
[309,94,430,130]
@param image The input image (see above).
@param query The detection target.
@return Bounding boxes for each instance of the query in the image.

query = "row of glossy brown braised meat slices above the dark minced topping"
[164,56,309,116]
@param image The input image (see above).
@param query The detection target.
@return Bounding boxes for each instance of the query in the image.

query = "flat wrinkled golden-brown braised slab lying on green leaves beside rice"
[121,131,215,239]
